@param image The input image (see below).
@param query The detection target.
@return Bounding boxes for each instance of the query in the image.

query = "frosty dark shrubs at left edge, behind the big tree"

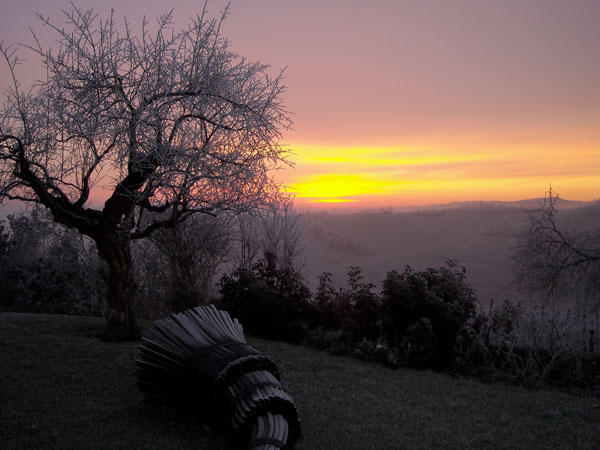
[0,207,105,315]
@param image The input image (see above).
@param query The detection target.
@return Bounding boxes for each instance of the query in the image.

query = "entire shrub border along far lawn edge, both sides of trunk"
[0,208,600,390]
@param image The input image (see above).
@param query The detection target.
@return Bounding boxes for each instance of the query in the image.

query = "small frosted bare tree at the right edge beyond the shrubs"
[513,188,600,311]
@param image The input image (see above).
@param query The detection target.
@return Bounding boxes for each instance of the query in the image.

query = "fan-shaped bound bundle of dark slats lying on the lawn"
[136,305,300,450]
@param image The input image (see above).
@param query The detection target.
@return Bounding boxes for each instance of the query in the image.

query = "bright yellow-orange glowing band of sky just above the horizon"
[281,143,600,208]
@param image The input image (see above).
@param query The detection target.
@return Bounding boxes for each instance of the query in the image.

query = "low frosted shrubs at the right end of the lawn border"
[455,300,600,393]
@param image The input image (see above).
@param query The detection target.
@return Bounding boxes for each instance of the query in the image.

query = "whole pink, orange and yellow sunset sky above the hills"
[0,0,600,209]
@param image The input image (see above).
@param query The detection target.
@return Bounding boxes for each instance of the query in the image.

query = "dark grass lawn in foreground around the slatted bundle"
[0,313,600,450]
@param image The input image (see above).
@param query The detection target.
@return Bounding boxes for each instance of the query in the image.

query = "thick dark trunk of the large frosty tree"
[97,231,141,341]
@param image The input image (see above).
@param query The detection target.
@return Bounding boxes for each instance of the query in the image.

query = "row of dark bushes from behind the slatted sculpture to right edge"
[221,255,600,391]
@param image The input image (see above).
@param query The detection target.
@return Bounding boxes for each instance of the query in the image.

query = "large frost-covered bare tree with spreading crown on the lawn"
[0,5,290,339]
